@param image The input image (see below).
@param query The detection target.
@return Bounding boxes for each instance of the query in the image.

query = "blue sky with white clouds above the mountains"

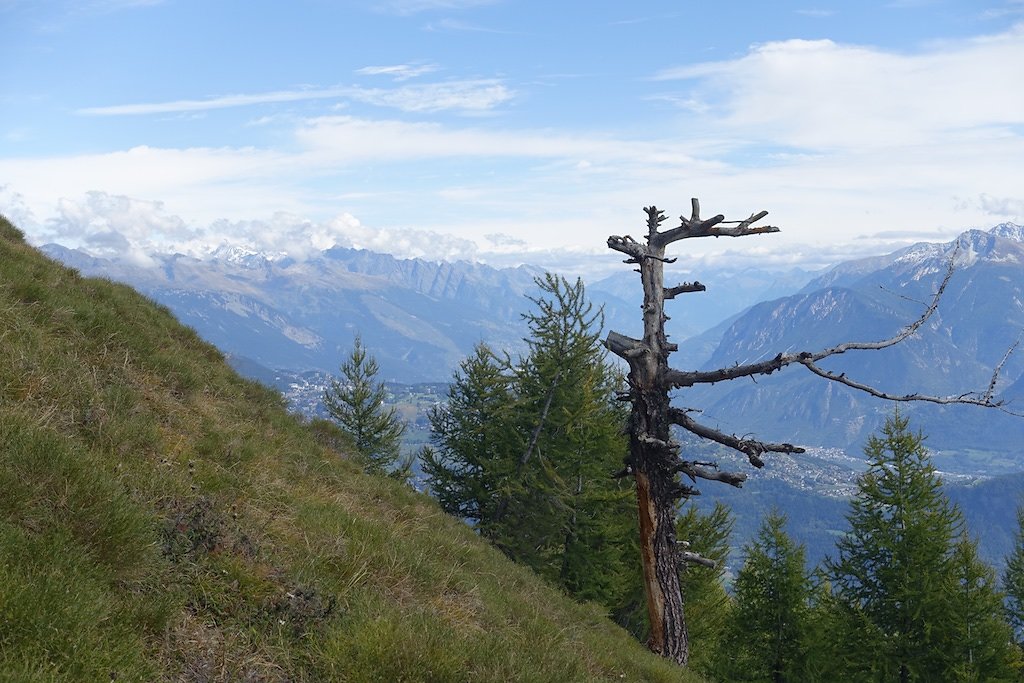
[0,0,1024,272]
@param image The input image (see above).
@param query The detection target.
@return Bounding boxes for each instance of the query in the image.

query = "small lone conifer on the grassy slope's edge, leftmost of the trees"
[324,336,408,476]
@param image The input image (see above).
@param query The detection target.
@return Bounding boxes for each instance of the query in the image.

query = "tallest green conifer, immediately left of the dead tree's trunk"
[499,273,633,601]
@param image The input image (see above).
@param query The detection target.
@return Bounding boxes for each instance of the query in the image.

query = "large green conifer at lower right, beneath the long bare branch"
[827,413,1006,681]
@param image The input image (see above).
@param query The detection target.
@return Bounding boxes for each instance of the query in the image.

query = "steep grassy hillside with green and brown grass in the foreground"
[0,218,689,681]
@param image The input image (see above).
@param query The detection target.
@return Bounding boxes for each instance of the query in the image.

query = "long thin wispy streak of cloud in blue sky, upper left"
[77,79,513,116]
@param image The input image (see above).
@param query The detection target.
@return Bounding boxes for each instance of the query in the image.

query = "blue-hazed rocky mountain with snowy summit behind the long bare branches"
[679,223,1024,469]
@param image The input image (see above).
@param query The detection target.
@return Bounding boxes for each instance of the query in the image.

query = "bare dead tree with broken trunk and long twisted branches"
[604,199,1013,666]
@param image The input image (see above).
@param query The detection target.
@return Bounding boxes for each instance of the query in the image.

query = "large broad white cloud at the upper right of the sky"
[655,25,1024,150]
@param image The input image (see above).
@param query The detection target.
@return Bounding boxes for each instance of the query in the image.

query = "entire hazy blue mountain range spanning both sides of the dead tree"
[43,223,1024,466]
